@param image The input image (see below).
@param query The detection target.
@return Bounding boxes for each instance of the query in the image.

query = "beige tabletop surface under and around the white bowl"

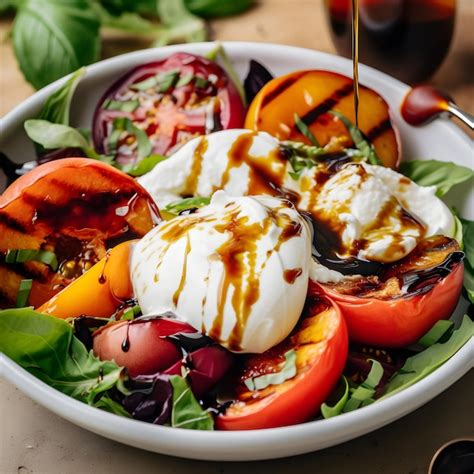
[0,0,474,474]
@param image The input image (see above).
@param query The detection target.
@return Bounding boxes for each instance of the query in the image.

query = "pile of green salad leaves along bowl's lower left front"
[0,308,213,430]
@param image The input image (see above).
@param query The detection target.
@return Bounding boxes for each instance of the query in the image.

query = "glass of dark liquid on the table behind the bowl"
[324,0,456,84]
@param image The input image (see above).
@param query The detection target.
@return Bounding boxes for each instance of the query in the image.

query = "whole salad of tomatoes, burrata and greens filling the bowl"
[0,42,474,431]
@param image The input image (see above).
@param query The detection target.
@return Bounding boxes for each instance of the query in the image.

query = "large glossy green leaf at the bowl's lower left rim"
[0,308,124,405]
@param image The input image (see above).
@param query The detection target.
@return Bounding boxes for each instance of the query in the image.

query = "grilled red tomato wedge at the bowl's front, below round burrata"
[216,299,348,430]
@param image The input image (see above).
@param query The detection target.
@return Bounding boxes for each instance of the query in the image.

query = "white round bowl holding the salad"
[0,42,474,461]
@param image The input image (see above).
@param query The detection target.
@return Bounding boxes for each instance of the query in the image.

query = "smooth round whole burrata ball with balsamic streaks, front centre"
[131,191,311,353]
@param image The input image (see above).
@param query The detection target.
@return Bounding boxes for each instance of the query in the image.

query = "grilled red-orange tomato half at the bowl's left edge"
[0,158,160,307]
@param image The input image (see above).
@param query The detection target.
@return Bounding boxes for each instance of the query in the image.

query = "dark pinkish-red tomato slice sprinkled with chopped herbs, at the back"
[93,53,245,164]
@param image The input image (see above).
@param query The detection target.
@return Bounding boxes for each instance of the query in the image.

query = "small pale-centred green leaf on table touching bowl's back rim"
[154,0,207,46]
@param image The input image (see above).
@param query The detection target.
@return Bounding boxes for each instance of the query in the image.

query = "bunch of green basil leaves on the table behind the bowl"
[0,0,253,89]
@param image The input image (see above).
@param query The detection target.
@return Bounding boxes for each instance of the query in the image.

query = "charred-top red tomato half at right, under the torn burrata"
[309,236,464,347]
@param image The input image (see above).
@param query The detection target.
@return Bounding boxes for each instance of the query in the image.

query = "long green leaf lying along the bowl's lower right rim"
[380,315,474,399]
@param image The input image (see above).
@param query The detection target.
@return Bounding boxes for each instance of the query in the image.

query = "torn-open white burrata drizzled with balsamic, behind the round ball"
[139,129,454,282]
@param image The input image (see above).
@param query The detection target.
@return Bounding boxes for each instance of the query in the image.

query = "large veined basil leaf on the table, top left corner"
[12,0,100,89]
